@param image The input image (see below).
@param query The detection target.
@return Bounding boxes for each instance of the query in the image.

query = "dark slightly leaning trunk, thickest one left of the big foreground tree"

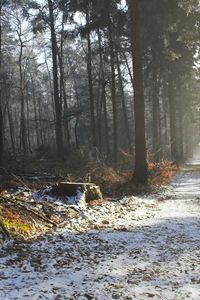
[48,0,63,158]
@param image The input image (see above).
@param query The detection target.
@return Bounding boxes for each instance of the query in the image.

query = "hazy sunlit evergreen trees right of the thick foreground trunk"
[140,0,199,163]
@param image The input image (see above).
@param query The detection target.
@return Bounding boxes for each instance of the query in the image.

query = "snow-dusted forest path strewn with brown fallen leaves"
[0,167,200,300]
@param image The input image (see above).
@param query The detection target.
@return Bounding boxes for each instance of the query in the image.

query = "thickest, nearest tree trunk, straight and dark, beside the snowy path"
[130,0,148,184]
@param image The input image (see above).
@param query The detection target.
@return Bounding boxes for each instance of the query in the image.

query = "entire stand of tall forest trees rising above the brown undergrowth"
[0,0,199,183]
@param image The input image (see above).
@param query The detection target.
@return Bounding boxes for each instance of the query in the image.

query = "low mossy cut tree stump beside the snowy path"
[49,182,103,202]
